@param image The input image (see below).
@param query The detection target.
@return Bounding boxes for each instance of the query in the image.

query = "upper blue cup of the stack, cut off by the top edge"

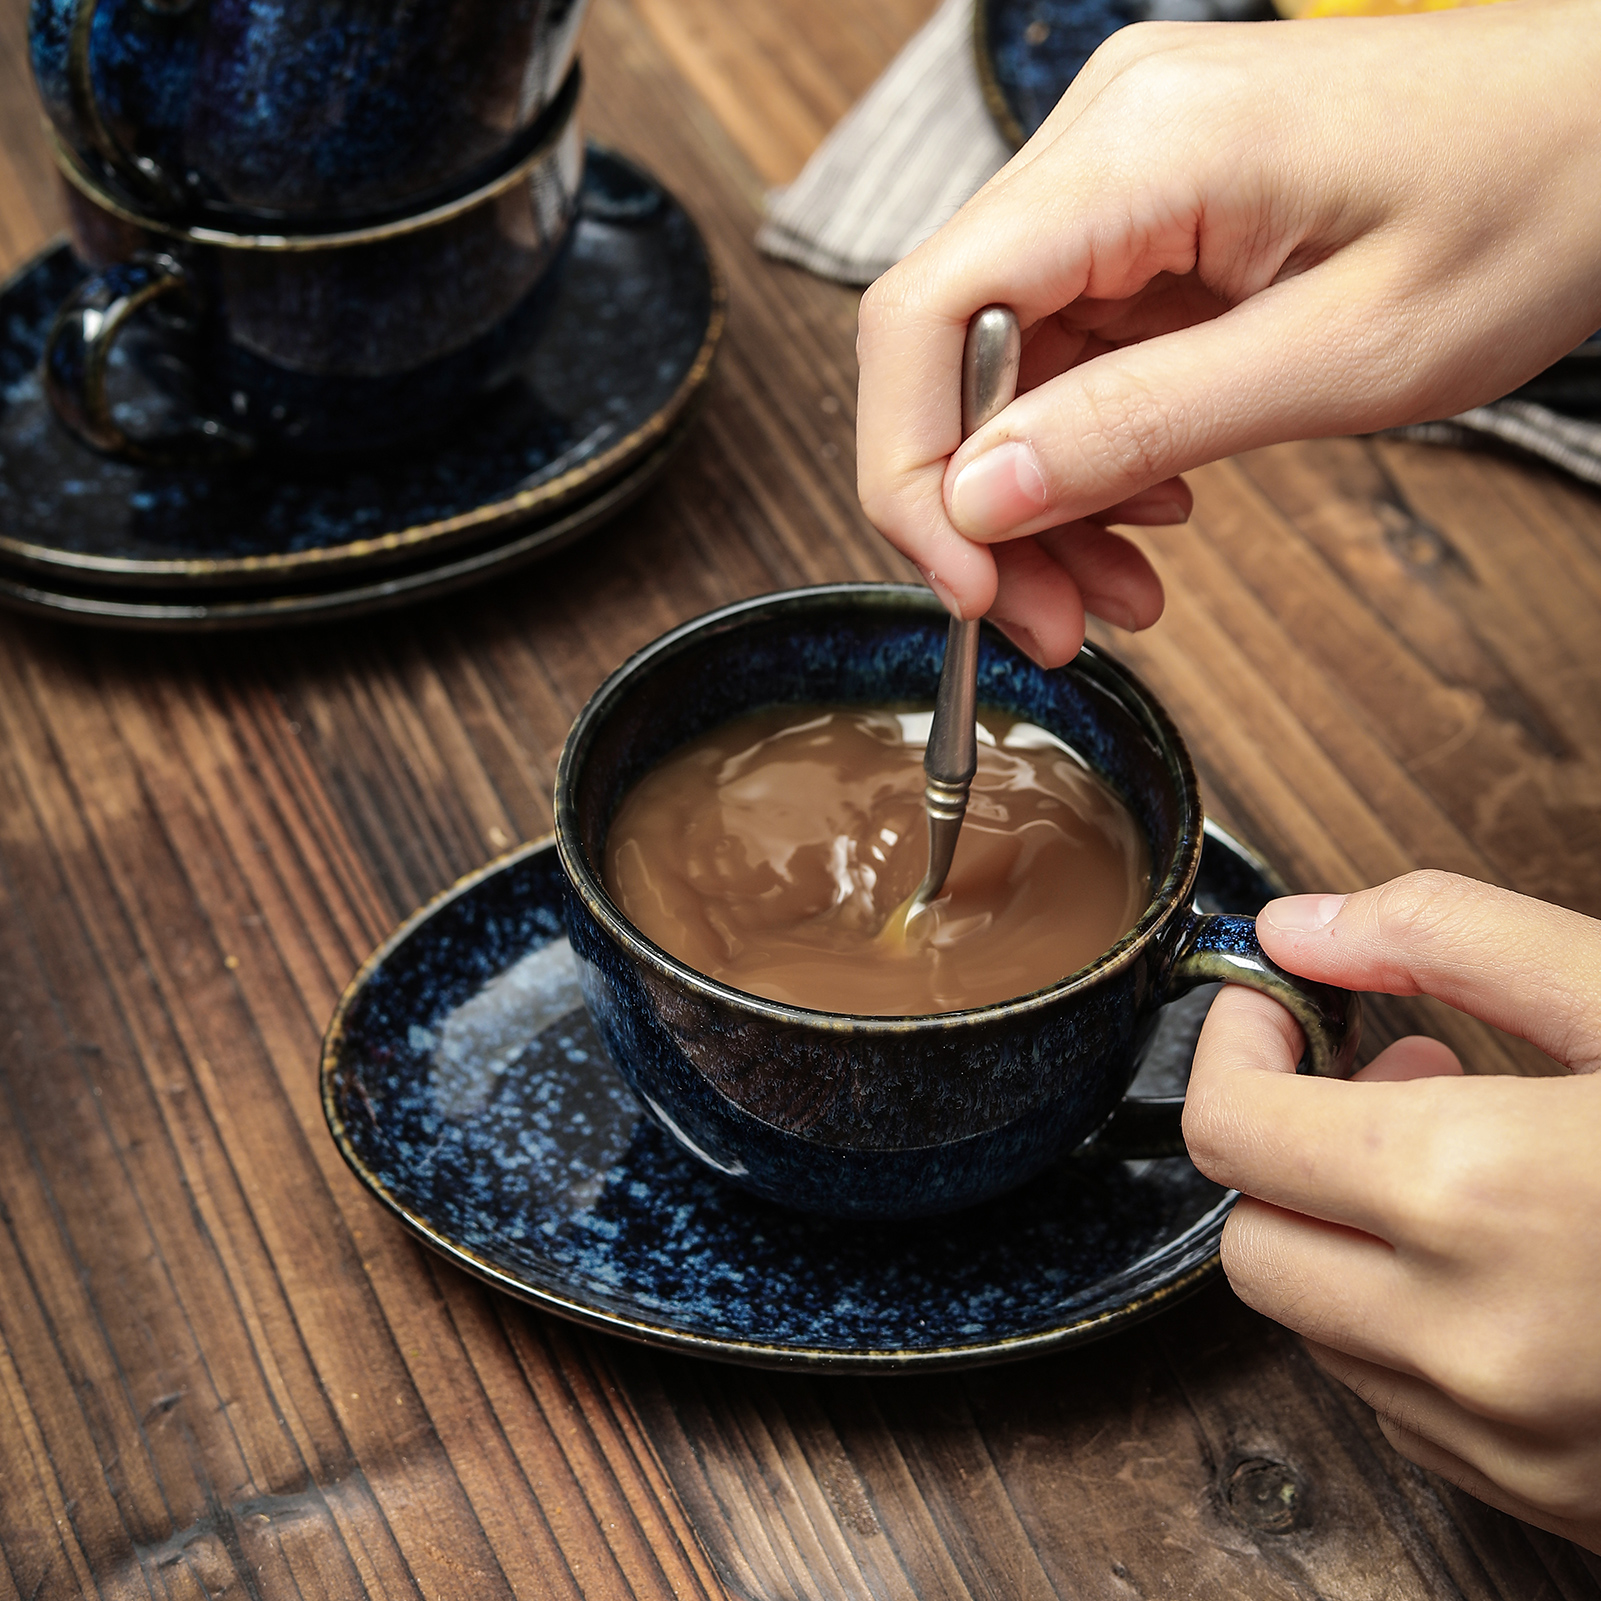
[29,0,588,232]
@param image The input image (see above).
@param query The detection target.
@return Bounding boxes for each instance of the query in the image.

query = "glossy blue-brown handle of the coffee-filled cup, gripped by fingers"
[1092,908,1362,1159]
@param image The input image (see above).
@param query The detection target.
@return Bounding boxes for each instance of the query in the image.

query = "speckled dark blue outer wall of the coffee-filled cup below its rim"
[568,934,1156,1218]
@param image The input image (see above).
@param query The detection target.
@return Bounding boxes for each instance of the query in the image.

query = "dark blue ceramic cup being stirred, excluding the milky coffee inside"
[556,584,1361,1218]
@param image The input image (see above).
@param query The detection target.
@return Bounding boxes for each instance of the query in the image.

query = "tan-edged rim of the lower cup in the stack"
[45,59,583,253]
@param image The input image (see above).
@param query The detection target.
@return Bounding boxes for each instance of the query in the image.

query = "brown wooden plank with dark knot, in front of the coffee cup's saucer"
[618,1289,1593,1601]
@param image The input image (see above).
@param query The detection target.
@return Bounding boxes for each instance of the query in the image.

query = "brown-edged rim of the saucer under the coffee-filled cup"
[319,820,1255,1374]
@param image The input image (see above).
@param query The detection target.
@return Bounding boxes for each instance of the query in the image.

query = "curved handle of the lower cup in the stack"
[40,253,255,466]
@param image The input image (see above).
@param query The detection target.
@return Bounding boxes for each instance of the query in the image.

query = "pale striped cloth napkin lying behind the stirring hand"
[756,0,1601,485]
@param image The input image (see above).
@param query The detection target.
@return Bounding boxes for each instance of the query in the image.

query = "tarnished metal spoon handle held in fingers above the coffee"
[914,306,1023,905]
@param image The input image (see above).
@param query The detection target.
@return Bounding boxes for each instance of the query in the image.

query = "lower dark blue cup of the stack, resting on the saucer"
[43,64,583,464]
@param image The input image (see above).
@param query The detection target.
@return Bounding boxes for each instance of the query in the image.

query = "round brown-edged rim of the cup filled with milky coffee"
[556,583,1204,1036]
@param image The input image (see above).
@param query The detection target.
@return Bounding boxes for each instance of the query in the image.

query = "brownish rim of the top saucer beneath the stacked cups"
[0,139,728,588]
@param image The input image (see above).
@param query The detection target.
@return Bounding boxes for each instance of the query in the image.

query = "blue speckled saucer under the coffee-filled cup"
[322,825,1281,1372]
